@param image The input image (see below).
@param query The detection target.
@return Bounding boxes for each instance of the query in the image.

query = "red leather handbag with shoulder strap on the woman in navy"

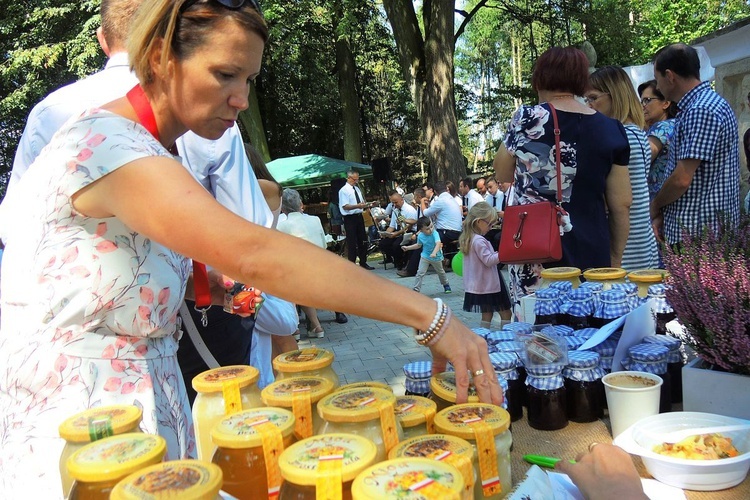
[498,103,565,264]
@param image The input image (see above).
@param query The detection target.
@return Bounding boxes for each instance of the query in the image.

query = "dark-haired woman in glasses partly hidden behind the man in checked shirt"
[638,80,677,200]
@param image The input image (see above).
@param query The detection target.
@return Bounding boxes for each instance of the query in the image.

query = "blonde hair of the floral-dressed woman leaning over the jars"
[127,0,268,85]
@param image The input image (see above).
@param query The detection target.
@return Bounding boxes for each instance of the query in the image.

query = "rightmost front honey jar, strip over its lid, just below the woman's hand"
[435,403,513,500]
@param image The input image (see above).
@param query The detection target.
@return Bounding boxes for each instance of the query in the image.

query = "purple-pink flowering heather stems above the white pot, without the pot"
[664,215,750,375]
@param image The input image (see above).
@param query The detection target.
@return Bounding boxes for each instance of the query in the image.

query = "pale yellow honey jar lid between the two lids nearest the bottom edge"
[279,434,378,486]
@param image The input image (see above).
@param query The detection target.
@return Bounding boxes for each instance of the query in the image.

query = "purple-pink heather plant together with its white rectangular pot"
[664,215,750,418]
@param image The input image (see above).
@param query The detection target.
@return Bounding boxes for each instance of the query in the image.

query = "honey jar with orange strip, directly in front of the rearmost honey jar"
[260,375,333,439]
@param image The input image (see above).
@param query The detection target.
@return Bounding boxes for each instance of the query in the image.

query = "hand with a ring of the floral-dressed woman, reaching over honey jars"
[430,317,504,406]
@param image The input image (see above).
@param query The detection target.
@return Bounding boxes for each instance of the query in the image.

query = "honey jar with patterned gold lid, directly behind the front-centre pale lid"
[316,387,404,461]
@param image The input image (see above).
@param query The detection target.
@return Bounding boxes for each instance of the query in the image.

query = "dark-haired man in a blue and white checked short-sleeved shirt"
[651,43,740,248]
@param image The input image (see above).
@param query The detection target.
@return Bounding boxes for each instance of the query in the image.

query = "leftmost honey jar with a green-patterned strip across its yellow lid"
[58,405,143,498]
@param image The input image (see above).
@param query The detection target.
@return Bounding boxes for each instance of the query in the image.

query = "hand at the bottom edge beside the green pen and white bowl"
[555,443,648,500]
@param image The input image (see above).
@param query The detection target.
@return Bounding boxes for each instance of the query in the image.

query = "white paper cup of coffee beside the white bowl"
[602,371,664,438]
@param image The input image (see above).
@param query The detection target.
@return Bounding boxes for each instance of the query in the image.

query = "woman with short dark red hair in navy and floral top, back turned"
[494,47,631,314]
